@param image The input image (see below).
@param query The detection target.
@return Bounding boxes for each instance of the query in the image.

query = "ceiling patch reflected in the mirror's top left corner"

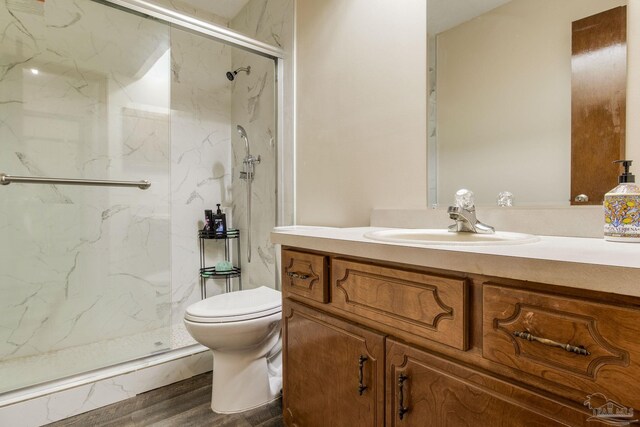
[427,0,511,34]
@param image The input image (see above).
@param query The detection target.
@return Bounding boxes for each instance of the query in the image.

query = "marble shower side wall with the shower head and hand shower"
[229,0,293,288]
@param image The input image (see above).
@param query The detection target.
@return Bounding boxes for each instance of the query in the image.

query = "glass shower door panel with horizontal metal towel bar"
[0,0,171,393]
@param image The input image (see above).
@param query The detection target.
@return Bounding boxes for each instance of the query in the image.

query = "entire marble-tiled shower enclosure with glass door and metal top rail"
[0,0,282,397]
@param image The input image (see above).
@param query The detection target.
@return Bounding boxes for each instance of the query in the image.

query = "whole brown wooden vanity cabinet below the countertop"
[283,248,640,427]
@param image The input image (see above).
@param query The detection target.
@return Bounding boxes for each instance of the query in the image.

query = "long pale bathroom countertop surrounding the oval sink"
[271,226,640,297]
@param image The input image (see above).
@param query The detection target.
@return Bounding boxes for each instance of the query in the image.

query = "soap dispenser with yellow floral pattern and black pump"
[604,160,640,242]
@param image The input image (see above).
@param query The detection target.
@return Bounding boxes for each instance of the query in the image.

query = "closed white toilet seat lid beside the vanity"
[184,286,282,323]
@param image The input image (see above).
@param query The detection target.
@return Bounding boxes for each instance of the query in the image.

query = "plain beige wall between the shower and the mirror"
[296,0,427,226]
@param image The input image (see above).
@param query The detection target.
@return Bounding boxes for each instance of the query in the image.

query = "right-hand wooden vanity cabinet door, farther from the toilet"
[386,339,600,427]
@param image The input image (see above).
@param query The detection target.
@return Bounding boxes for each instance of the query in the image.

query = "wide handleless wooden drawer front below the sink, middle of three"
[331,259,468,350]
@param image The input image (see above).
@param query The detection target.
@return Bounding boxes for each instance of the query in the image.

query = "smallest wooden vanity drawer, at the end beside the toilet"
[282,249,329,303]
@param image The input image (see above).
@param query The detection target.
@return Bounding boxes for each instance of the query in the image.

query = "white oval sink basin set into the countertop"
[364,228,540,246]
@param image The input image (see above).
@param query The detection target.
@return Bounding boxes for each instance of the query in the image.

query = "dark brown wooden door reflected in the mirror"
[571,6,627,205]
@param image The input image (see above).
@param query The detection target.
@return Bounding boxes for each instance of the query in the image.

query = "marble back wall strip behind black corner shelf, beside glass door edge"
[171,28,233,325]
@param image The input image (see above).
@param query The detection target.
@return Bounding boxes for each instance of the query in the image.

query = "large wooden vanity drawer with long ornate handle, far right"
[482,283,640,409]
